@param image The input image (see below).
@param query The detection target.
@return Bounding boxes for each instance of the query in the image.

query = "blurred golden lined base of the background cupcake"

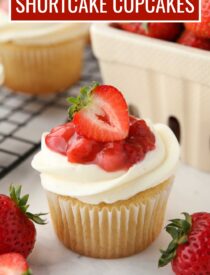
[0,37,86,95]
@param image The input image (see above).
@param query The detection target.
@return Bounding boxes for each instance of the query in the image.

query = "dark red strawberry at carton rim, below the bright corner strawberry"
[177,31,210,51]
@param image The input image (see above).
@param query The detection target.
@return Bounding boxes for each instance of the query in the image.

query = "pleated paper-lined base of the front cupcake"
[47,179,172,259]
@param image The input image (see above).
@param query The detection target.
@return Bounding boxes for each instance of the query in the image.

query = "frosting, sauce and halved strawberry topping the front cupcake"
[32,84,179,204]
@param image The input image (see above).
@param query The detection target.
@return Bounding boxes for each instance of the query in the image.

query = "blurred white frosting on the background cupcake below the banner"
[0,11,89,45]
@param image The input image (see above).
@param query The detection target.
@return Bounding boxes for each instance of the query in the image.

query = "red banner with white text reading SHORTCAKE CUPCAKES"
[10,0,200,21]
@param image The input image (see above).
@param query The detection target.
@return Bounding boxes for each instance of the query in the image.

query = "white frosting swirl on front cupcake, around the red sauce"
[32,124,179,204]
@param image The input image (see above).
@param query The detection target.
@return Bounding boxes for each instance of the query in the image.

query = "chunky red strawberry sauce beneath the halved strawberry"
[45,117,155,172]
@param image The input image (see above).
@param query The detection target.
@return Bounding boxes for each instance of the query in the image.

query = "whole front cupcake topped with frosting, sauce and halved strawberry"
[32,84,179,259]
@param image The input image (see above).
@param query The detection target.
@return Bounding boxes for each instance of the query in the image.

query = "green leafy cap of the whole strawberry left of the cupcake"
[9,185,47,224]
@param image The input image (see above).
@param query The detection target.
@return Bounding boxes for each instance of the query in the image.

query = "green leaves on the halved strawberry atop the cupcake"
[67,82,99,120]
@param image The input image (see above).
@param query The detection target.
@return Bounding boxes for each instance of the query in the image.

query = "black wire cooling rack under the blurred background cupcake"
[0,47,101,179]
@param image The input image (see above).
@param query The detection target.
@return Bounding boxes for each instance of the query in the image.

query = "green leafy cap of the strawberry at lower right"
[158,213,192,267]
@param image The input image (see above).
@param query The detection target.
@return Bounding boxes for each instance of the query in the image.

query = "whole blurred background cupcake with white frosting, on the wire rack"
[0,3,88,95]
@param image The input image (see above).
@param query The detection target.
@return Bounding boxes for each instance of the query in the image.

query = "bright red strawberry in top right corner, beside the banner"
[185,0,210,39]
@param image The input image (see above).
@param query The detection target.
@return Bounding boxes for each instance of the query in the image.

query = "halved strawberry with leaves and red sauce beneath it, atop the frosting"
[45,83,155,172]
